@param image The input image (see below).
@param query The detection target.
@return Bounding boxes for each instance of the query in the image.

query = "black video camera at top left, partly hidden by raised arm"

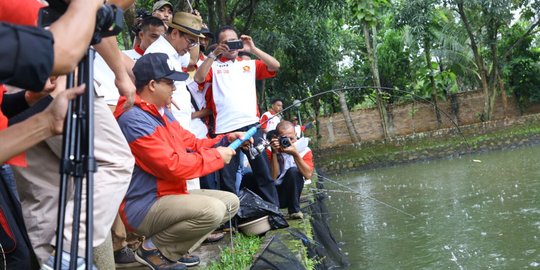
[38,0,124,45]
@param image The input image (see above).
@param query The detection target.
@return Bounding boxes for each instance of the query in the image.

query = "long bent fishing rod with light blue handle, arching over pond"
[229,86,471,150]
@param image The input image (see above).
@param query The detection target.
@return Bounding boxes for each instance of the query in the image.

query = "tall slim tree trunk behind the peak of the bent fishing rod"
[363,23,390,140]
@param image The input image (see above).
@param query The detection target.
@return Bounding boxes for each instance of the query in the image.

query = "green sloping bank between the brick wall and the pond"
[315,114,540,174]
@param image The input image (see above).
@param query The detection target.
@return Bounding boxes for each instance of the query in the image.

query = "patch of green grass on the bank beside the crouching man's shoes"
[207,233,262,270]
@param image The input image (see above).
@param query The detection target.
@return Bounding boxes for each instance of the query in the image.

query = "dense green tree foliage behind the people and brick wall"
[129,0,540,121]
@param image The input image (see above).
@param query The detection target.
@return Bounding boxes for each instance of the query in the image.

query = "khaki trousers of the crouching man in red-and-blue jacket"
[138,189,240,261]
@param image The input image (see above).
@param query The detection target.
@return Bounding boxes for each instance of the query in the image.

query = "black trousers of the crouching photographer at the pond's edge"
[276,167,304,214]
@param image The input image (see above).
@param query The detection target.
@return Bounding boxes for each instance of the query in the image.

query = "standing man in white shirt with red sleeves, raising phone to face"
[194,26,280,204]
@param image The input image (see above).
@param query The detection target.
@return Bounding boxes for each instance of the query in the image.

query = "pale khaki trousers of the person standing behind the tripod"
[14,97,135,262]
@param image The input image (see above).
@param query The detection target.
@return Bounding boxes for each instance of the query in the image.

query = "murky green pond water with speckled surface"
[325,146,540,269]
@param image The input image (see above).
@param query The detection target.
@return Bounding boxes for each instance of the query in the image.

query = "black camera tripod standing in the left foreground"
[54,48,97,270]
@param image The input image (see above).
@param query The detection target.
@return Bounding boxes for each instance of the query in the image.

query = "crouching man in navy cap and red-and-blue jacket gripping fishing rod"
[115,53,243,269]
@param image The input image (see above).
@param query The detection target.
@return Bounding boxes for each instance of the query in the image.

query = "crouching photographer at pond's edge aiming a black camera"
[268,121,314,219]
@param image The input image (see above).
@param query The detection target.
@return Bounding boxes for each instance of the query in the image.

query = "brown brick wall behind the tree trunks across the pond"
[318,91,539,149]
